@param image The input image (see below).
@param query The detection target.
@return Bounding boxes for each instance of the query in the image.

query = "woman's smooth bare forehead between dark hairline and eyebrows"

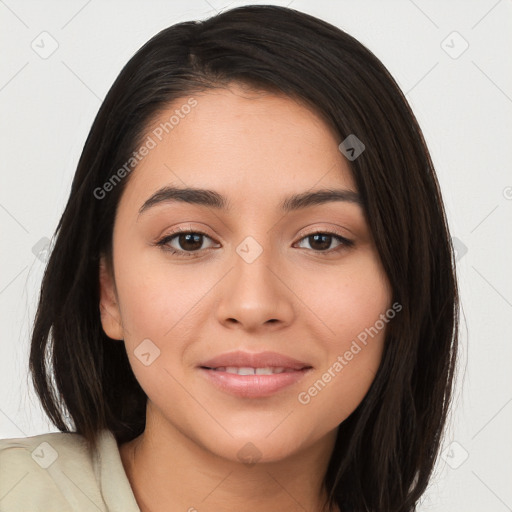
[117,86,356,213]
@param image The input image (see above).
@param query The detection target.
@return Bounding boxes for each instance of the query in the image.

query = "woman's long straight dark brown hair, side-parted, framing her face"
[30,6,458,512]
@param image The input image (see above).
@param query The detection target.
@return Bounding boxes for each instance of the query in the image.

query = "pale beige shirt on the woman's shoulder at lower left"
[0,430,140,512]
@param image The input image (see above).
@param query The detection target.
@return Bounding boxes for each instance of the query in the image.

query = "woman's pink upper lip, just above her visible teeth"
[199,351,311,370]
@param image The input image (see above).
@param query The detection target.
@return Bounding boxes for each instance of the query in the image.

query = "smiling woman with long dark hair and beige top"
[0,6,458,512]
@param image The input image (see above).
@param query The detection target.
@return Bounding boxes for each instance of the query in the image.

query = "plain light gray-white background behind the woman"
[0,0,512,512]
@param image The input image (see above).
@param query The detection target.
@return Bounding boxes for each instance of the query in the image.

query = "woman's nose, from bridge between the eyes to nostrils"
[216,239,295,332]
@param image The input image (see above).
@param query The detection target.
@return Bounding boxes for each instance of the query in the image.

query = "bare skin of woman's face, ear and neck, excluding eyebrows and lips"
[100,84,391,512]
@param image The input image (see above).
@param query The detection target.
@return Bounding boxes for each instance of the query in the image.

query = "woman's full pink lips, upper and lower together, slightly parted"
[198,351,313,398]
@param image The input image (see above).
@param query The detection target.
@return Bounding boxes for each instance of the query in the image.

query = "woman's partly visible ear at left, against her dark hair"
[99,255,124,340]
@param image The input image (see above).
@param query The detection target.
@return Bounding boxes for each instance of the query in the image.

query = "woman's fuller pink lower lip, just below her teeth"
[200,368,311,398]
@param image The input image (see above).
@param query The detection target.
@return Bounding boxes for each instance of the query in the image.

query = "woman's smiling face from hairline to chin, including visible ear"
[100,85,391,462]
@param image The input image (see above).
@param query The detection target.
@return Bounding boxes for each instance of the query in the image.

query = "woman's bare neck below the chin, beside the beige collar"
[120,406,336,512]
